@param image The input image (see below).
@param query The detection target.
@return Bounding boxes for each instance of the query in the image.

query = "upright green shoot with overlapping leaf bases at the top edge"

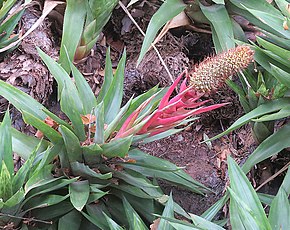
[59,0,118,71]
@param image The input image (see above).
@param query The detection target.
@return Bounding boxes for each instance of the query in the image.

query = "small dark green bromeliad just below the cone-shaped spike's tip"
[228,63,289,144]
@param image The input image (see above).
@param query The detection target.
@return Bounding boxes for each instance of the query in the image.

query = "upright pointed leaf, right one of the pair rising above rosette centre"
[103,50,126,124]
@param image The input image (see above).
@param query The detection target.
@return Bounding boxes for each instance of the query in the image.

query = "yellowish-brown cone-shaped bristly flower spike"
[189,46,254,92]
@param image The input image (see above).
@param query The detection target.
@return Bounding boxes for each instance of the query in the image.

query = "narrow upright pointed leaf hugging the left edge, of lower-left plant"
[0,109,14,177]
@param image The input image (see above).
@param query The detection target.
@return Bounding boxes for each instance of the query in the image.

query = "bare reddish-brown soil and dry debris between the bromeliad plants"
[0,1,284,223]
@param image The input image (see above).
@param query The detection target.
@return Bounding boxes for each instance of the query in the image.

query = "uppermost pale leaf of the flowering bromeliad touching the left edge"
[0,80,46,120]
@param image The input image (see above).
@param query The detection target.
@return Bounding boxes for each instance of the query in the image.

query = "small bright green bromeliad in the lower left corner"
[0,112,77,229]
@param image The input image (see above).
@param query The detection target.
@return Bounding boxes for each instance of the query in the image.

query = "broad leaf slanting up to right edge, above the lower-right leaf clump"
[242,124,290,173]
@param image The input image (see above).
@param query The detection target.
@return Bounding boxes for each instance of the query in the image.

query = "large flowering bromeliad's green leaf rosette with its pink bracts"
[0,45,250,229]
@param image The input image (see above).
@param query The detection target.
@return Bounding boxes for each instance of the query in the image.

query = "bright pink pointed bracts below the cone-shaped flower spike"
[115,71,227,138]
